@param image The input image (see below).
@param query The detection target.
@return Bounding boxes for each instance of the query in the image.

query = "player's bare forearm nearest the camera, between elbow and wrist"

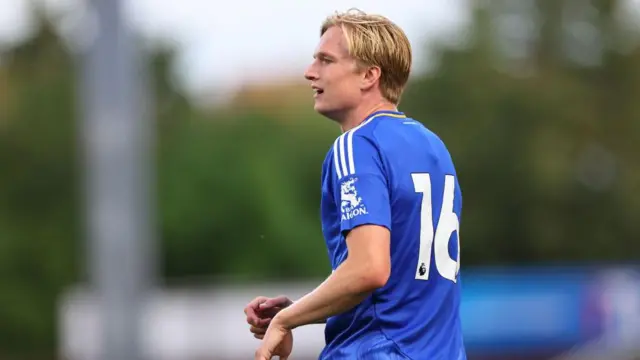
[274,260,377,329]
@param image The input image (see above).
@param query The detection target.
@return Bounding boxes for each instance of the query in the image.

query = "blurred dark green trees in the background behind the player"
[0,1,640,359]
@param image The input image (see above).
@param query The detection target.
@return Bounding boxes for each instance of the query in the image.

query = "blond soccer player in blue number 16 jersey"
[245,10,466,360]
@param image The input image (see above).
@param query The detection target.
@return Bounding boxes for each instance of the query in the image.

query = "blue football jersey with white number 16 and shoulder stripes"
[320,111,466,360]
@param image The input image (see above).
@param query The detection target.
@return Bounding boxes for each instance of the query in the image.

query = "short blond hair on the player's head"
[320,9,412,105]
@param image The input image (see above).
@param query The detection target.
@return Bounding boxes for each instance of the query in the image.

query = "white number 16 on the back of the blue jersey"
[411,173,460,282]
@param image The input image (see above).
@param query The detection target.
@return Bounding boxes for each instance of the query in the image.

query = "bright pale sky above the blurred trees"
[0,0,469,97]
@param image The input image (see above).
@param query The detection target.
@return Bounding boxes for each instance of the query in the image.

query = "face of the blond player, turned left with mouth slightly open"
[305,26,362,119]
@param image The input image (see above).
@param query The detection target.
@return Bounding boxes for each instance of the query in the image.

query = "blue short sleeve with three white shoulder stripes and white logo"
[333,132,391,233]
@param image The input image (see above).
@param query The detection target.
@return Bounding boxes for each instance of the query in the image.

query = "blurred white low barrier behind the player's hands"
[58,282,324,360]
